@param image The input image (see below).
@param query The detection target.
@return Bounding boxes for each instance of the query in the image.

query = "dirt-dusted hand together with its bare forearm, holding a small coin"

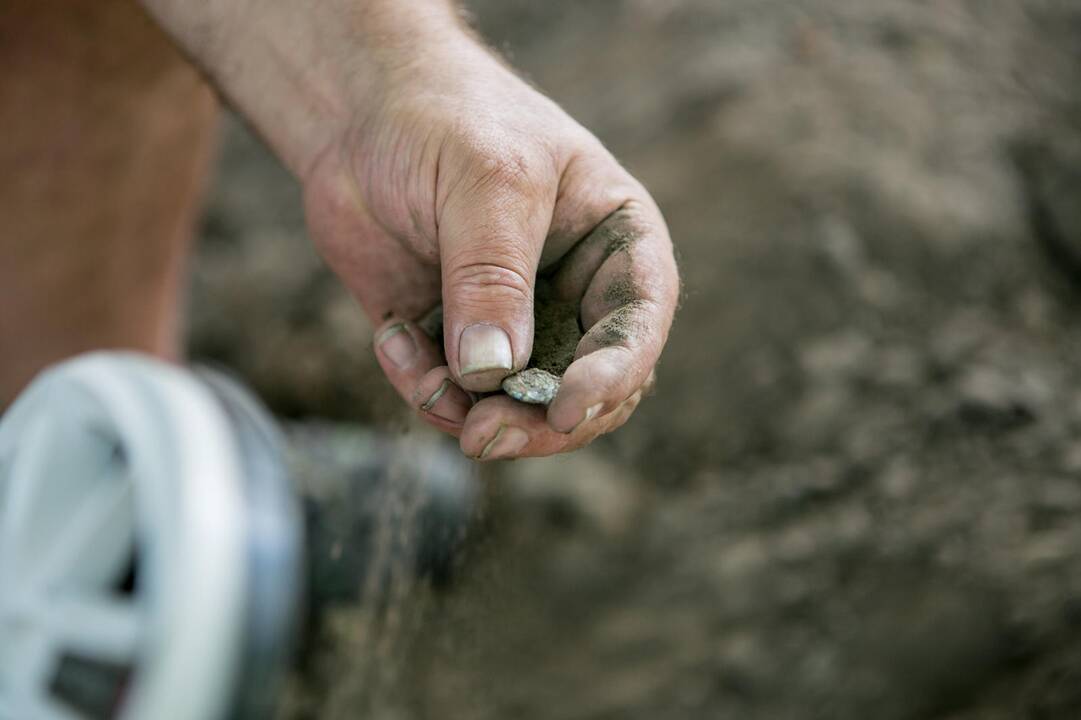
[140,0,679,458]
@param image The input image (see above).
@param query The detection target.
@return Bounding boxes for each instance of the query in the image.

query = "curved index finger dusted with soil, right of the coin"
[547,201,679,432]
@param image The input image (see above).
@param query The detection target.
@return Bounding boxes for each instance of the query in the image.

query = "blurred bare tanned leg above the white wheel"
[0,0,216,410]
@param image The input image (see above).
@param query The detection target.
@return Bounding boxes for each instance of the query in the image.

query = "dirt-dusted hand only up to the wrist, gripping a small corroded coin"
[307,33,678,457]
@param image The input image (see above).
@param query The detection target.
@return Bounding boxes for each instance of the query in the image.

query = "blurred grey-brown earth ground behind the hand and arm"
[189,0,1081,720]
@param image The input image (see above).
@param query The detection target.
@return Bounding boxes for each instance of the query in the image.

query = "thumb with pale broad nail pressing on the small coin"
[439,164,555,391]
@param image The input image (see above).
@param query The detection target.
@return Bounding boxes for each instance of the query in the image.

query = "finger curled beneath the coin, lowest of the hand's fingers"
[461,392,642,461]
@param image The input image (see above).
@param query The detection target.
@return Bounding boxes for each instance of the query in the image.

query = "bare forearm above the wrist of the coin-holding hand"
[142,0,469,177]
